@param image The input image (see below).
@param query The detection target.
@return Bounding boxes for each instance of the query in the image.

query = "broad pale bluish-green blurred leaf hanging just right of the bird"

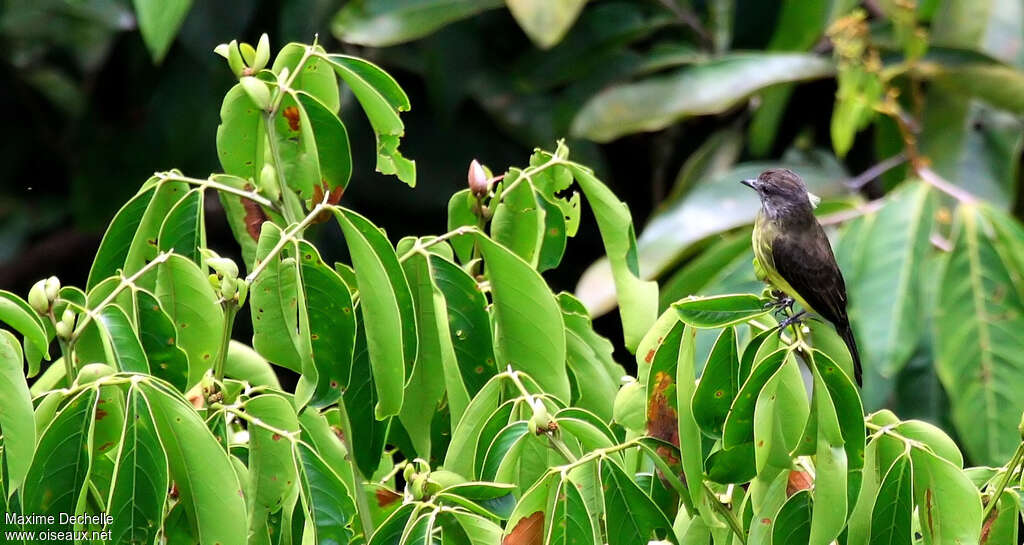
[847,182,933,377]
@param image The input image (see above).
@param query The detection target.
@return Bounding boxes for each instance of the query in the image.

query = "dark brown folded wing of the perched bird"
[771,223,848,324]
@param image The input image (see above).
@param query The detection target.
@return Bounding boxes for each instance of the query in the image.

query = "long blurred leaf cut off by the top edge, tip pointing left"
[331,0,502,47]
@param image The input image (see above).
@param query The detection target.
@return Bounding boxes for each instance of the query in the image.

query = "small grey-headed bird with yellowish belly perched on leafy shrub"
[741,168,862,385]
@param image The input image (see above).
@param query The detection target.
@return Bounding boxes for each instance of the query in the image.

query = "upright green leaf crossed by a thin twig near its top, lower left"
[244,393,299,512]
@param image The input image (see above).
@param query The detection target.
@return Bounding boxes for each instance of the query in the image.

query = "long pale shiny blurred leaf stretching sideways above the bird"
[571,53,835,142]
